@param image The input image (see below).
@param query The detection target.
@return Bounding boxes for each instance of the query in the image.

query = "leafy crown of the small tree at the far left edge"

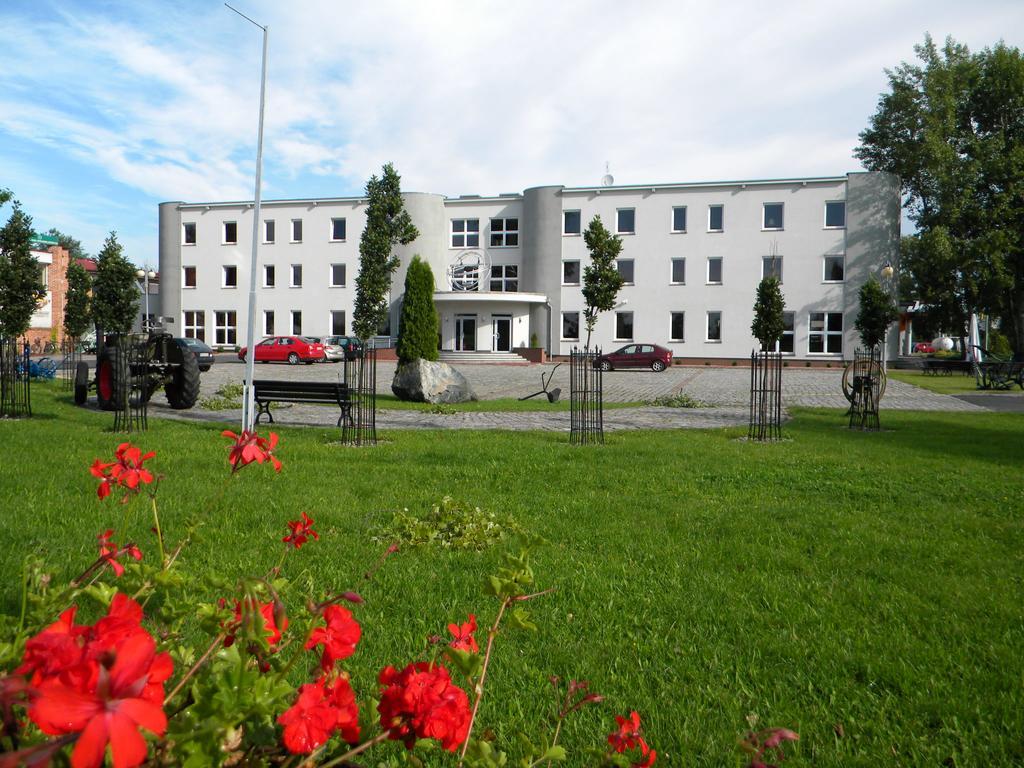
[0,201,46,337]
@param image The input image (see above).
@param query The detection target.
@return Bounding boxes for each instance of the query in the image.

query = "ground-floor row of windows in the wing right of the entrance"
[561,310,843,354]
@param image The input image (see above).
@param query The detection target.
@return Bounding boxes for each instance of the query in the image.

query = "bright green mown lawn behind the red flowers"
[6,386,1024,768]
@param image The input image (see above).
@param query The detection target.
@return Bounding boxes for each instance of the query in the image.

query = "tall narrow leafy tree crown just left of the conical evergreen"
[352,163,420,339]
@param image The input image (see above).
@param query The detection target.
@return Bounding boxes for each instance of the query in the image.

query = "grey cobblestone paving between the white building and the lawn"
[142,355,987,432]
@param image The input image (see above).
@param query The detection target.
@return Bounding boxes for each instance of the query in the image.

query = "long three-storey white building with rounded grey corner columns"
[160,173,900,360]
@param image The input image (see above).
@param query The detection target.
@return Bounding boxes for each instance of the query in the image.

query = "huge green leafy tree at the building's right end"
[855,36,1024,354]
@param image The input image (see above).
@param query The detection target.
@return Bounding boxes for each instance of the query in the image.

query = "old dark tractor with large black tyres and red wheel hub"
[75,331,199,411]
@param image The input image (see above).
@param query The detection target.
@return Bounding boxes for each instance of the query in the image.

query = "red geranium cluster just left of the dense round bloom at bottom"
[278,676,359,755]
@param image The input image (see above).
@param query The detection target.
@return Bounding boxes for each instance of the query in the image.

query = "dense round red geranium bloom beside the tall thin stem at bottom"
[377,662,471,752]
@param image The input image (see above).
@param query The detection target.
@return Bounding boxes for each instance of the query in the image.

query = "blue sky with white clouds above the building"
[0,0,1024,265]
